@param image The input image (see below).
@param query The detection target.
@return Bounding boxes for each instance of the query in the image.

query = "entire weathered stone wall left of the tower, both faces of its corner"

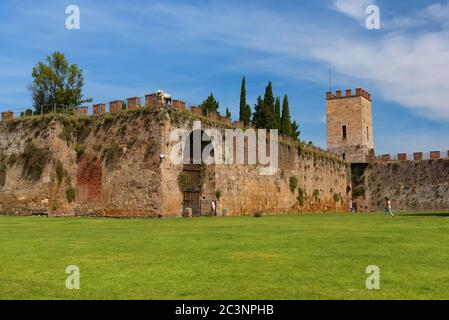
[0,95,351,217]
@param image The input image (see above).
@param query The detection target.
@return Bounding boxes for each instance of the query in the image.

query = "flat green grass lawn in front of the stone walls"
[0,214,449,299]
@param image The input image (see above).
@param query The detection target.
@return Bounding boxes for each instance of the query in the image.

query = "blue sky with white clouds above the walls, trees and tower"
[0,0,449,153]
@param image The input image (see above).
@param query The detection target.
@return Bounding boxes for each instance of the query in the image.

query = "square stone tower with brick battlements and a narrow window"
[326,88,374,163]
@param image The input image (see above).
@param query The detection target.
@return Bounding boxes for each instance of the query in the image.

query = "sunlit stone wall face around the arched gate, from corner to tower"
[158,108,350,215]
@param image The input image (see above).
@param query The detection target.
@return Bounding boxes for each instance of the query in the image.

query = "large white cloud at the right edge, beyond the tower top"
[314,31,449,121]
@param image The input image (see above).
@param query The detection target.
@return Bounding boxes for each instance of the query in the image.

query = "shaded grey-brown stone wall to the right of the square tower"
[352,157,449,211]
